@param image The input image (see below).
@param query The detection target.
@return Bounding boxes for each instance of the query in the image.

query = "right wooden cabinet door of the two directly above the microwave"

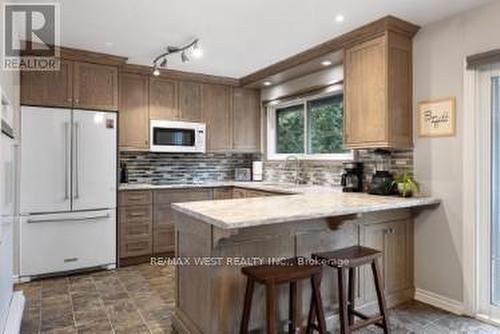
[179,81,201,122]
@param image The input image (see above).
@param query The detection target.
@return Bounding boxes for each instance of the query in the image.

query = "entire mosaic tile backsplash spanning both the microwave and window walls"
[120,150,413,186]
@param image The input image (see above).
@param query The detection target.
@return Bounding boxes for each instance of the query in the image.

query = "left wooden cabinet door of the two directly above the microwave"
[149,78,179,121]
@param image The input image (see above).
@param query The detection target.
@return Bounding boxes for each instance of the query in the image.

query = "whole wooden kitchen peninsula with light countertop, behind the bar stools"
[167,188,439,334]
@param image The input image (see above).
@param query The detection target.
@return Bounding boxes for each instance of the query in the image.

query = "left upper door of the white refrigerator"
[20,107,71,213]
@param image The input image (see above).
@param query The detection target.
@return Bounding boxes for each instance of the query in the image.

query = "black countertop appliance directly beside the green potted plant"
[368,150,394,196]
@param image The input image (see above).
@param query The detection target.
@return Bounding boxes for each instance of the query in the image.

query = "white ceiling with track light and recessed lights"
[26,0,491,78]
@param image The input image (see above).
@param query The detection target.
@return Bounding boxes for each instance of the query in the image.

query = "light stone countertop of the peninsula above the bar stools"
[172,191,440,229]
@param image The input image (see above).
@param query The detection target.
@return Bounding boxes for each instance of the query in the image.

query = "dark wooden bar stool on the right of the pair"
[312,246,390,334]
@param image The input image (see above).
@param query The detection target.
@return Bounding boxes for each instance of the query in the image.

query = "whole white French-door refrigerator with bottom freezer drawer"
[20,107,117,280]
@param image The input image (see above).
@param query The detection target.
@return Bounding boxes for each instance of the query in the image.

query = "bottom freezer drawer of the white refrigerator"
[21,210,116,277]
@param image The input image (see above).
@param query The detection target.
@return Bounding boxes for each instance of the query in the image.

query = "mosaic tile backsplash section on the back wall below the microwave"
[120,152,260,184]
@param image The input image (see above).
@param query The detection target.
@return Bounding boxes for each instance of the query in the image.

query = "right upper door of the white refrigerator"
[72,110,117,211]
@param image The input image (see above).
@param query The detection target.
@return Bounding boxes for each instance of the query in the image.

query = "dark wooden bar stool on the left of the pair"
[240,259,326,334]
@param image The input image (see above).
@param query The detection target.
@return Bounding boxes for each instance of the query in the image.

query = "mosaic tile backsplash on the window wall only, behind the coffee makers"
[264,150,413,186]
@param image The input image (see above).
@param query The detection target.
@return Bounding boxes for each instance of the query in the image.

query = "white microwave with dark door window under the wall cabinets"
[149,120,206,153]
